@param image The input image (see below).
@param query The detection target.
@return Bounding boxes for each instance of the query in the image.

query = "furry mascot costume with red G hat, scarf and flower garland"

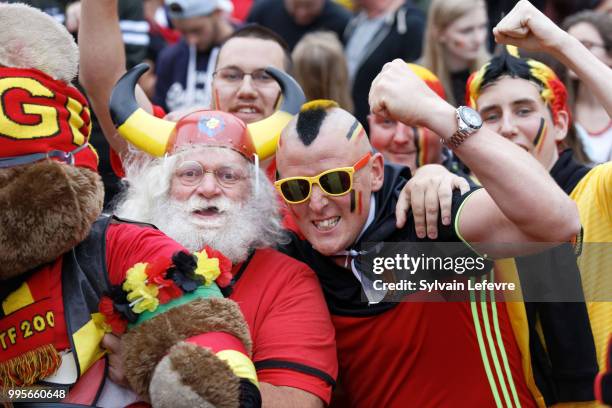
[0,4,286,407]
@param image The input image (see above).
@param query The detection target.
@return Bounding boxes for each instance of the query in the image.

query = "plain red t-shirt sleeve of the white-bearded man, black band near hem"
[230,249,338,403]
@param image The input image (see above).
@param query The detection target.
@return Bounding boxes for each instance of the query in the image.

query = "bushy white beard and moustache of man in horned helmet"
[150,196,261,264]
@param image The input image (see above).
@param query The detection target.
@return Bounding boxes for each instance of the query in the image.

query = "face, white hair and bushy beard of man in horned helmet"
[115,147,286,264]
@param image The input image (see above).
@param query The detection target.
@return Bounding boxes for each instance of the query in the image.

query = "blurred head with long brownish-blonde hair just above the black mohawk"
[291,31,353,112]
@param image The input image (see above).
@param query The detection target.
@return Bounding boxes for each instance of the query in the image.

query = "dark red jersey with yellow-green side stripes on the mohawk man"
[332,302,536,408]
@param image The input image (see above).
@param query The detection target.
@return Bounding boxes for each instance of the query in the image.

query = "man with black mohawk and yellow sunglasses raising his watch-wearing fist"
[275,60,579,407]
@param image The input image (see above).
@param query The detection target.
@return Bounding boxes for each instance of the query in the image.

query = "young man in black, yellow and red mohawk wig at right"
[466,47,612,406]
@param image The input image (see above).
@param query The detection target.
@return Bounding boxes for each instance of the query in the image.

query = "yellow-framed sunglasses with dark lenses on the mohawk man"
[274,152,372,204]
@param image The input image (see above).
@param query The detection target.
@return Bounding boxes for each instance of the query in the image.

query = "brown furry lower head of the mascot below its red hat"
[0,160,104,280]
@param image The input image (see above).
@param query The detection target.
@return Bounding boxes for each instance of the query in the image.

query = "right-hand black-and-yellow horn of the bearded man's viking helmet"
[247,67,306,160]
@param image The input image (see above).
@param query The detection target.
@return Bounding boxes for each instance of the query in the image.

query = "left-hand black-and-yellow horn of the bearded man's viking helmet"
[109,63,176,157]
